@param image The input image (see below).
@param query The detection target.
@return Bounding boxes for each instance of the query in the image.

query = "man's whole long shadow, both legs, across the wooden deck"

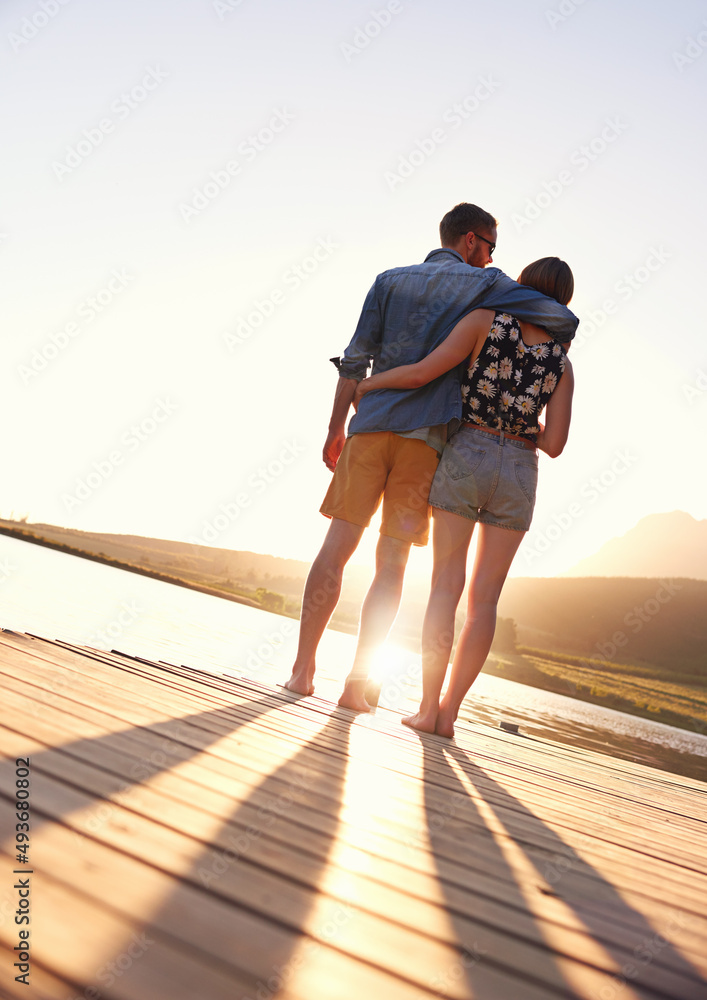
[0,652,354,1000]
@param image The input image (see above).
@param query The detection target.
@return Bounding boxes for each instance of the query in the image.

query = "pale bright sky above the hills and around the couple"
[0,0,707,575]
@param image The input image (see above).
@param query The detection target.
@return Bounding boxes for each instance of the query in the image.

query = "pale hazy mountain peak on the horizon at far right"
[561,510,707,580]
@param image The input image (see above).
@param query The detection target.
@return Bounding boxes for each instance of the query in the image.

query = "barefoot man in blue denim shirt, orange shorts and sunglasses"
[285,202,578,712]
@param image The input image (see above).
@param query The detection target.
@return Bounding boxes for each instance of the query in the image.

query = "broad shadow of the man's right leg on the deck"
[126,709,354,1000]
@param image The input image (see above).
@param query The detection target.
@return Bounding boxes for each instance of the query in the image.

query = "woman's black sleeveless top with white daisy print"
[462,312,565,442]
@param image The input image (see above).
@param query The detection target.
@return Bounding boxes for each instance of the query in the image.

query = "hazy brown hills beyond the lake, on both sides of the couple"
[0,519,707,676]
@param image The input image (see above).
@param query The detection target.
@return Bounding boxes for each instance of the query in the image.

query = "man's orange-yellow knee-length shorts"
[319,431,439,545]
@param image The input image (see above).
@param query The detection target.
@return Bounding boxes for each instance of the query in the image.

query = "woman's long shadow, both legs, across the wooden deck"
[422,740,707,1000]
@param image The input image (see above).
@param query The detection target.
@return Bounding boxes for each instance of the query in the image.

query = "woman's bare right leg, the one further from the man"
[435,524,525,736]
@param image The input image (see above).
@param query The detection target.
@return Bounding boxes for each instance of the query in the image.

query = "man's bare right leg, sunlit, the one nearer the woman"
[339,535,412,712]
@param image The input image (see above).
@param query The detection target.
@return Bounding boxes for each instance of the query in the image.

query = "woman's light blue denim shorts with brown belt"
[430,426,538,531]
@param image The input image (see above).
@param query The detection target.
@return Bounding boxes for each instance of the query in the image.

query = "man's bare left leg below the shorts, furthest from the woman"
[285,517,365,694]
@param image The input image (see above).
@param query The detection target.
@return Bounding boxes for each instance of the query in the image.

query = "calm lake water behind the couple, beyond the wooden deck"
[0,536,707,781]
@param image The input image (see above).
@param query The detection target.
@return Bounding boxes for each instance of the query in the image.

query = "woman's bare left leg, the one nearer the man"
[403,508,475,733]
